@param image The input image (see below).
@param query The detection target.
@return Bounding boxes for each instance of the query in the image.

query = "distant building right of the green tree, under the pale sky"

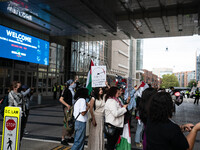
[174,71,195,87]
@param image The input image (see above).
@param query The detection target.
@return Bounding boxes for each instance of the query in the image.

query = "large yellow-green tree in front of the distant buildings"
[161,74,179,88]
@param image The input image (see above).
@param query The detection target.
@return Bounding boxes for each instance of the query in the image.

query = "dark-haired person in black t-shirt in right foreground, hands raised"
[145,92,200,150]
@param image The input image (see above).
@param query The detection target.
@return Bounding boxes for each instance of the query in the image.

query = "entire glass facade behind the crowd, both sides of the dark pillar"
[0,41,105,95]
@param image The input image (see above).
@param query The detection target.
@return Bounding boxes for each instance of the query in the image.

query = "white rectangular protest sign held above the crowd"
[92,66,106,87]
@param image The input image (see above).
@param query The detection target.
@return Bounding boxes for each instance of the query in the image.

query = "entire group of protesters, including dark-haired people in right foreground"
[60,77,200,150]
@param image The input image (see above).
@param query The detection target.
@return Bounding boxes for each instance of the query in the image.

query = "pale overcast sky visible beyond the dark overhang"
[143,35,200,72]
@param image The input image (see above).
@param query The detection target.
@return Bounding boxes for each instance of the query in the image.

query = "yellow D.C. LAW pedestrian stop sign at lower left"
[1,107,21,150]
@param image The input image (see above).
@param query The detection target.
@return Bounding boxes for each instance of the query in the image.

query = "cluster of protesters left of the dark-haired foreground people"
[59,79,134,150]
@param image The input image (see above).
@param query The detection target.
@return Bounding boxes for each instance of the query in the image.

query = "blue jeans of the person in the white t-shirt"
[71,121,86,150]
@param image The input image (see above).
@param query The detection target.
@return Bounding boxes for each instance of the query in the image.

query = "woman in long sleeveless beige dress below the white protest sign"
[88,87,105,150]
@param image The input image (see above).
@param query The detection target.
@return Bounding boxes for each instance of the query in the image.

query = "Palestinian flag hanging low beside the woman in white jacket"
[116,122,131,150]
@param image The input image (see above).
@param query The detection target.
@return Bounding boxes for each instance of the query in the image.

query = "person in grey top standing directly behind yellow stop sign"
[8,81,26,141]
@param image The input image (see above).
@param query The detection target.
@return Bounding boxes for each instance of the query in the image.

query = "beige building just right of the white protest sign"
[106,39,137,85]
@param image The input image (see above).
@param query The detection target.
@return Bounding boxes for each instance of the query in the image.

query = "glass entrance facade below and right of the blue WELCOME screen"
[0,43,65,95]
